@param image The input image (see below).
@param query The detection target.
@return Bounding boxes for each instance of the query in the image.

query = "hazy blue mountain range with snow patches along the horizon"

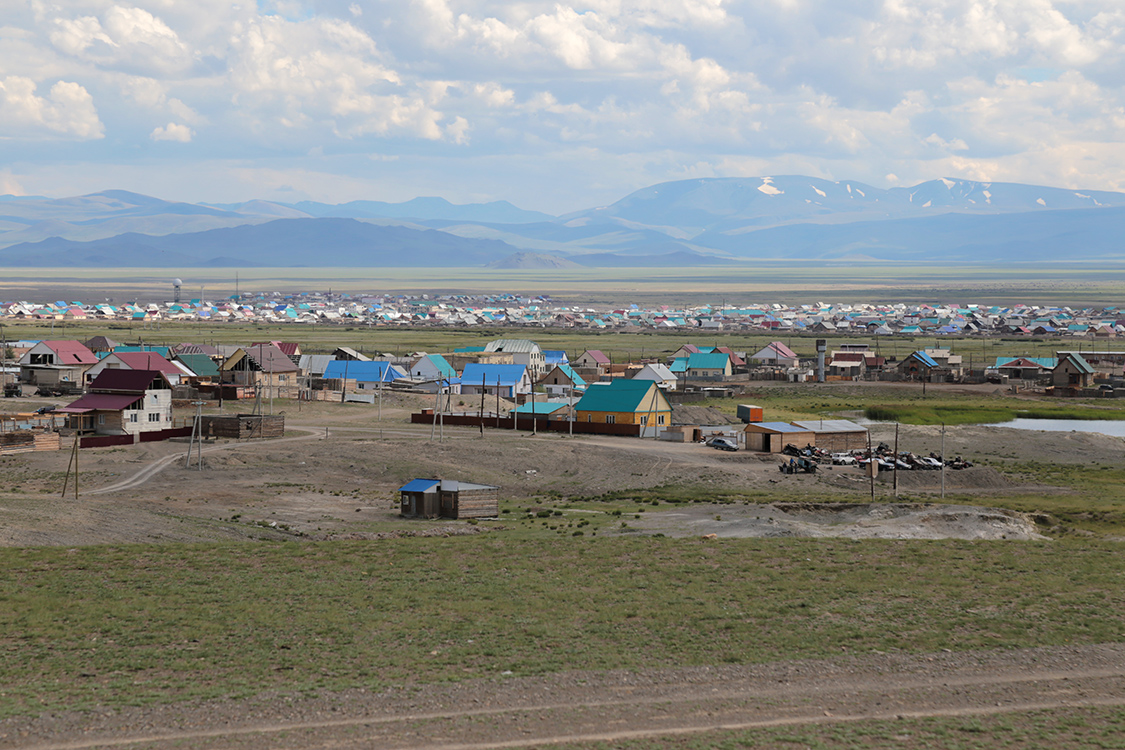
[0,175,1125,268]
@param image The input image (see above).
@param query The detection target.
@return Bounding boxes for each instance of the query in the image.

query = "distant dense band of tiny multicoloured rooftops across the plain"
[0,292,1125,337]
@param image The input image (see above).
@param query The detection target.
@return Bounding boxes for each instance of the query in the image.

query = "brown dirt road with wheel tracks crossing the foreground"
[8,644,1125,750]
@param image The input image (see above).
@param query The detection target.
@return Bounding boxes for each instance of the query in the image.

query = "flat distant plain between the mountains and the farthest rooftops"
[0,260,1125,307]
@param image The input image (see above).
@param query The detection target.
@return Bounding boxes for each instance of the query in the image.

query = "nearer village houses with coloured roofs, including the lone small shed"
[0,323,1125,532]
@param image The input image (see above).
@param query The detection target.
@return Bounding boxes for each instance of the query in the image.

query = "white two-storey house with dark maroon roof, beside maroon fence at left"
[56,370,172,435]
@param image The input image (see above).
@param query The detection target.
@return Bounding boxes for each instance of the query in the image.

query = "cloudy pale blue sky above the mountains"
[0,0,1125,215]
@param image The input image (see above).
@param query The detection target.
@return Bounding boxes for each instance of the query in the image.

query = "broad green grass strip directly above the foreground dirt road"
[0,533,1125,716]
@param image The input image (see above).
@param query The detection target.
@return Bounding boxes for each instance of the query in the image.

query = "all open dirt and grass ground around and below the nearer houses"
[0,278,1125,748]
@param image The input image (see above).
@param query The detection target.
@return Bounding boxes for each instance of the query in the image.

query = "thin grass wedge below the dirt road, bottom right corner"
[554,706,1125,750]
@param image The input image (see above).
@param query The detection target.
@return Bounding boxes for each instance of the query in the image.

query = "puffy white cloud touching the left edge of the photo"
[0,75,105,141]
